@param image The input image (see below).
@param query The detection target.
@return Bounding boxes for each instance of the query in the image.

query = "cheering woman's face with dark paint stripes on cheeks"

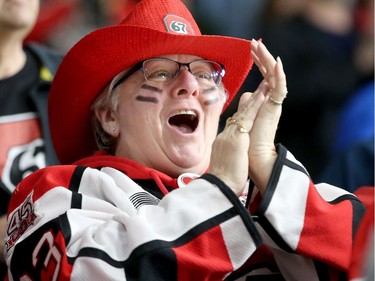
[98,55,225,176]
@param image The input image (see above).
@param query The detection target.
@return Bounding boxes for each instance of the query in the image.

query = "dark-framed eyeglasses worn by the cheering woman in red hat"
[113,58,225,89]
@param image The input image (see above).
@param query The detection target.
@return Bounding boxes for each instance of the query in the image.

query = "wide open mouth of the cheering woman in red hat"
[168,110,199,134]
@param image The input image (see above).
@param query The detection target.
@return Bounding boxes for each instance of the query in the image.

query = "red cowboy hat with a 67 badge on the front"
[48,0,253,164]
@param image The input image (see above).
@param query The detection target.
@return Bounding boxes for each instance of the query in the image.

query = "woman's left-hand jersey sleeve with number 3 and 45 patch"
[6,166,260,280]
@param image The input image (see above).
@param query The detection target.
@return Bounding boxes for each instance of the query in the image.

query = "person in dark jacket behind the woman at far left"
[0,0,62,280]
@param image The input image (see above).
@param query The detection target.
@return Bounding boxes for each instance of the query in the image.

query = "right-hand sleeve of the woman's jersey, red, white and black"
[250,145,365,280]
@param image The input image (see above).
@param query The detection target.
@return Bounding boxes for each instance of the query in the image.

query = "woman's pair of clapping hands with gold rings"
[210,40,287,195]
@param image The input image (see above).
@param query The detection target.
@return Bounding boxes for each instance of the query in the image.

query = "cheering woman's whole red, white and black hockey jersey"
[5,146,364,281]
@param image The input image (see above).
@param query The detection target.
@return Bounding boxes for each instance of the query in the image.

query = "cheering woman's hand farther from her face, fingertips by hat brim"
[247,40,287,193]
